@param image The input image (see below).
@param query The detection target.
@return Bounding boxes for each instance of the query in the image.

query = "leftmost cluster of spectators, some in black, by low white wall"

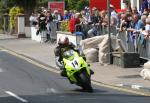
[29,7,63,42]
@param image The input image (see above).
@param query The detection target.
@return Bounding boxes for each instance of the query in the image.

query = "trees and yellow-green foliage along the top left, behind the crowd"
[0,0,89,31]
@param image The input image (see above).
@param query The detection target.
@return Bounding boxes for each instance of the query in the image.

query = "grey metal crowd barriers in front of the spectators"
[44,22,150,59]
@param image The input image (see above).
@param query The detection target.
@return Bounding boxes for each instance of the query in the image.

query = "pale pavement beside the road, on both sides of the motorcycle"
[0,34,150,96]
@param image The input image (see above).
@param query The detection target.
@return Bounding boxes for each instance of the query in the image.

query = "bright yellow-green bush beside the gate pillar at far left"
[9,6,24,27]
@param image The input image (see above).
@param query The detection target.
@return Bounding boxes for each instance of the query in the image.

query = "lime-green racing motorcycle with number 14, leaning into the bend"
[63,50,93,92]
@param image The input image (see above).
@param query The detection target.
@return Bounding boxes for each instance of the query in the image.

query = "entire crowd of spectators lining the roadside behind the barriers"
[29,1,150,41]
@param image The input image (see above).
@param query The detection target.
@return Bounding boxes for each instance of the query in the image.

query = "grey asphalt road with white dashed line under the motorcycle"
[0,51,150,103]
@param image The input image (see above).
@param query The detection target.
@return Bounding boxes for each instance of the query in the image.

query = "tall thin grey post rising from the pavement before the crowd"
[107,0,113,64]
